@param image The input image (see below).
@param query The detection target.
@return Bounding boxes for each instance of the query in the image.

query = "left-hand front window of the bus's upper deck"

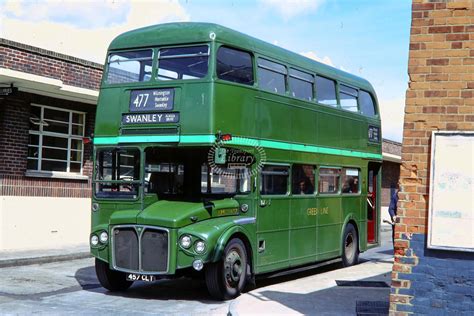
[106,49,153,84]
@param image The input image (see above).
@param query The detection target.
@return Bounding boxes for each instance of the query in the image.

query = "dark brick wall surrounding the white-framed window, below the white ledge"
[0,92,96,197]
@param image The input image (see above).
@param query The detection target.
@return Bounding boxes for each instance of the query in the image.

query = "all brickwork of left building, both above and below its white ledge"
[0,38,102,198]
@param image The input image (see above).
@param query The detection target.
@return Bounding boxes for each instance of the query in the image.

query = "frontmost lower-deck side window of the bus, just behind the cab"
[260,165,290,195]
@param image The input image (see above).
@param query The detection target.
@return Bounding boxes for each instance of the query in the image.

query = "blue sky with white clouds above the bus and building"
[0,0,411,141]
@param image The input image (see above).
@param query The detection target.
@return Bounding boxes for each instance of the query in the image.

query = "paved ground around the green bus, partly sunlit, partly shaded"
[0,228,392,315]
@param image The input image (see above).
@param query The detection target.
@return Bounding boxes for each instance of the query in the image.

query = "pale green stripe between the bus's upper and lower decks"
[94,135,382,160]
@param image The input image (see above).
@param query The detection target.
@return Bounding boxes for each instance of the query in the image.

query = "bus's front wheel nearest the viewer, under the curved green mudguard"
[205,238,248,300]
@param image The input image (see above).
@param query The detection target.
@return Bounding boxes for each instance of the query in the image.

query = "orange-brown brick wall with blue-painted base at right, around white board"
[390,0,474,315]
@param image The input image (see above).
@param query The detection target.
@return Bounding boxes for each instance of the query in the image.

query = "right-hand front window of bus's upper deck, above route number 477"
[157,45,209,80]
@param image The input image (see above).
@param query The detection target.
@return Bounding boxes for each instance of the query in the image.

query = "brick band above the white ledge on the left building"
[0,38,103,90]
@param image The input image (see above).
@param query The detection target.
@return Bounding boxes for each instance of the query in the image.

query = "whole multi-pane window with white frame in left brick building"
[27,104,86,174]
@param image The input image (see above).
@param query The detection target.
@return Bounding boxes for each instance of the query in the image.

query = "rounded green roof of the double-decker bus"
[109,22,375,94]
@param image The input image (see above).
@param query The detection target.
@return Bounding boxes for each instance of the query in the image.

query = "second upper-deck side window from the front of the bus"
[257,58,287,94]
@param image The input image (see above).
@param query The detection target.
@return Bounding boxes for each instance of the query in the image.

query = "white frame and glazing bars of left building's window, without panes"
[26,103,87,176]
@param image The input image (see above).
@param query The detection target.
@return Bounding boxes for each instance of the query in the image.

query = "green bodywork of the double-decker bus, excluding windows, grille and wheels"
[91,23,382,298]
